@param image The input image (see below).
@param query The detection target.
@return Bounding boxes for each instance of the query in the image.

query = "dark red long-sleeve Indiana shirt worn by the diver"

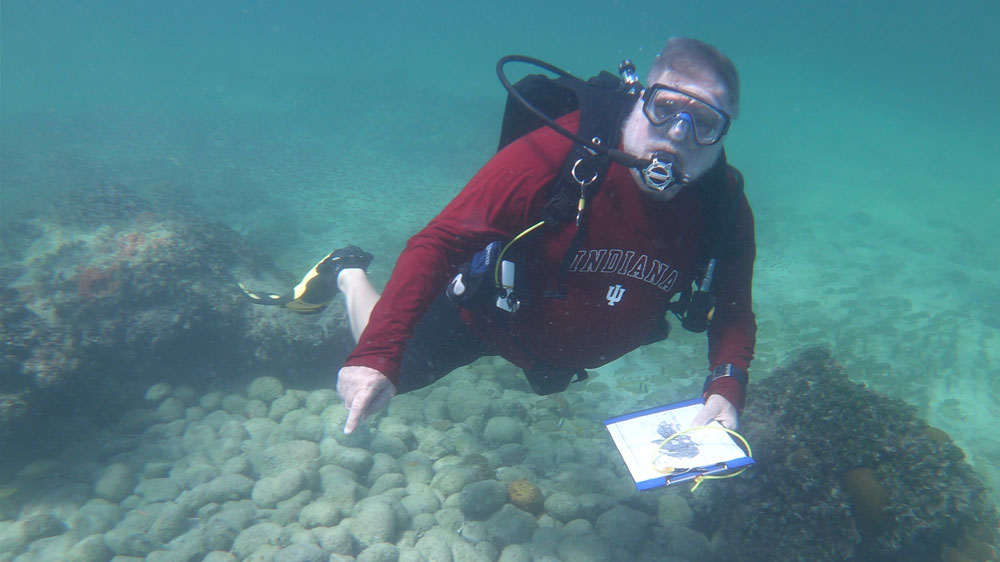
[345,113,756,408]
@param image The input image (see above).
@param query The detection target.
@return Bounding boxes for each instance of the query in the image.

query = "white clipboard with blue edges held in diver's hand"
[604,398,754,491]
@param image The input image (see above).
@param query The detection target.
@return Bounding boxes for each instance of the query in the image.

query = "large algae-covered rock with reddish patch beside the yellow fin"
[0,184,352,445]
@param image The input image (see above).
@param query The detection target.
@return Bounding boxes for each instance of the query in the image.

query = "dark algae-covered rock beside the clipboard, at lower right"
[693,349,997,562]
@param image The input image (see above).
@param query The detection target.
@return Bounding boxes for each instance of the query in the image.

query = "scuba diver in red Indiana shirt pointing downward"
[244,37,756,433]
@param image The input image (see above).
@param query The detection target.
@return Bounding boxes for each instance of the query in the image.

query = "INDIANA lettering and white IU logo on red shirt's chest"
[568,248,680,296]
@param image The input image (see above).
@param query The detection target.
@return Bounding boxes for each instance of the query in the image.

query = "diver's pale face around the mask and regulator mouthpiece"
[622,70,735,201]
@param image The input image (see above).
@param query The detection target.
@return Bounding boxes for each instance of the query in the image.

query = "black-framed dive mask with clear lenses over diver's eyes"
[642,84,731,146]
